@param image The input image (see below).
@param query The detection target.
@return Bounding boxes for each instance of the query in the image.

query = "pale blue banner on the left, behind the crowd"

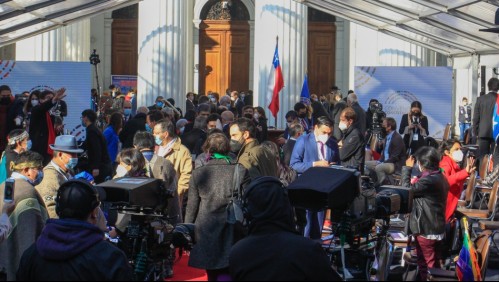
[0,60,92,141]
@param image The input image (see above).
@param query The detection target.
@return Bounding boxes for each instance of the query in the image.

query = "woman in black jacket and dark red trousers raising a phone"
[402,146,449,281]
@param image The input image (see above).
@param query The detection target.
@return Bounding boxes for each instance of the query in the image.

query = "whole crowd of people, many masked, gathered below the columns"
[0,77,499,280]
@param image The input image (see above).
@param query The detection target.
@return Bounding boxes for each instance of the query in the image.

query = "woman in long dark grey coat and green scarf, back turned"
[185,133,250,281]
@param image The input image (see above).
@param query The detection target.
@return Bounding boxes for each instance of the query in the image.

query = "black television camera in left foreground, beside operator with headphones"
[97,177,194,281]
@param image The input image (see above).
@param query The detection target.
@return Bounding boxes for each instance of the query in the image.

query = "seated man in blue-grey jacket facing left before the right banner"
[366,117,406,186]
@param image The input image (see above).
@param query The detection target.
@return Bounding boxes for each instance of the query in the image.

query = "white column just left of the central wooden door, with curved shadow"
[137,0,193,112]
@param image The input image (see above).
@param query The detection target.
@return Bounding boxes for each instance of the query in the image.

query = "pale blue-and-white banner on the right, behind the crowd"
[355,67,453,138]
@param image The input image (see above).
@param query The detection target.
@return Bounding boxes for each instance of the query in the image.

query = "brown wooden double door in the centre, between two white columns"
[198,20,250,94]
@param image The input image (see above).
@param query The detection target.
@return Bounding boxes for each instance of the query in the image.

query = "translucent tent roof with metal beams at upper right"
[295,0,499,56]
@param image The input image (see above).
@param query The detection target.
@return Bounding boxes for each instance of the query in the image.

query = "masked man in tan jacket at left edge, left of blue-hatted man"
[0,151,48,281]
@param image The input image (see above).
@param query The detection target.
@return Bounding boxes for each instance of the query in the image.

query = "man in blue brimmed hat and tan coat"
[36,135,83,218]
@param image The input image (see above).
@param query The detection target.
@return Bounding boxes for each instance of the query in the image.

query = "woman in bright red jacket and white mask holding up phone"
[440,139,475,222]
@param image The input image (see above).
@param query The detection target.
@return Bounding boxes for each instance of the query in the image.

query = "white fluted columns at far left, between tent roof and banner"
[16,19,90,62]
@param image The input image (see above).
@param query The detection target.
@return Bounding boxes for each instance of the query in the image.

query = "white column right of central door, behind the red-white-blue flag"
[253,0,308,128]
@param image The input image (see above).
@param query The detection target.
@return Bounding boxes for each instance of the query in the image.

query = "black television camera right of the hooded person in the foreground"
[288,166,413,279]
